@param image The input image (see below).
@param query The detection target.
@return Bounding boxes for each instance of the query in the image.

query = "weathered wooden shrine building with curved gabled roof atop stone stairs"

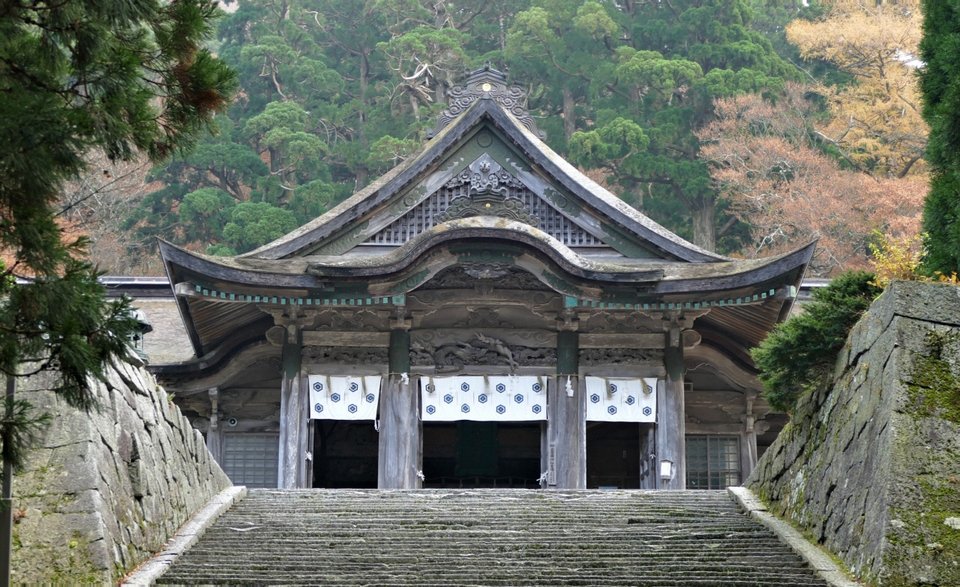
[153,67,814,489]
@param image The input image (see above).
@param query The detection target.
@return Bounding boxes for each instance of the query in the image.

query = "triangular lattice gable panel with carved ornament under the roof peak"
[364,156,607,247]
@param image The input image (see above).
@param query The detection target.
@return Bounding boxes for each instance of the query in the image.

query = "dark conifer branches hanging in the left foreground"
[0,0,235,464]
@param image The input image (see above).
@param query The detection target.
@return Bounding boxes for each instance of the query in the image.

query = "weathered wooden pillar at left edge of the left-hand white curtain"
[277,324,307,489]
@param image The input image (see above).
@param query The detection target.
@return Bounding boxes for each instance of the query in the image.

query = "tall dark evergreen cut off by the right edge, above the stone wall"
[920,0,960,275]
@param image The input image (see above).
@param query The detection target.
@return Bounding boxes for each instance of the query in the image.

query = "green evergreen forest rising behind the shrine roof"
[127,0,807,253]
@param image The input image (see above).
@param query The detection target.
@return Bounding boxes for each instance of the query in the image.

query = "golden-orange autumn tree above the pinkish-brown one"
[786,0,928,177]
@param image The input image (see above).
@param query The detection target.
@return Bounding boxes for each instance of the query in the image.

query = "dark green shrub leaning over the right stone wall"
[751,271,882,411]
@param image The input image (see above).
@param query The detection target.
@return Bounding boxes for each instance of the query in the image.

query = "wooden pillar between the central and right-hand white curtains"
[546,330,587,489]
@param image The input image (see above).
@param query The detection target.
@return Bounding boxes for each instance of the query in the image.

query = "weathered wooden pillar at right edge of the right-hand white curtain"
[654,322,686,489]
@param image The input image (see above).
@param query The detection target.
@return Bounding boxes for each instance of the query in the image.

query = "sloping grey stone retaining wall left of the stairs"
[12,356,230,584]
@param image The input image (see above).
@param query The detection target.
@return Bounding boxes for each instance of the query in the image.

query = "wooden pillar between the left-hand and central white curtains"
[377,325,421,489]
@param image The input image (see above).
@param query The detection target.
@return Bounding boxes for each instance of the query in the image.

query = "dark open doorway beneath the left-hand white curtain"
[313,420,380,489]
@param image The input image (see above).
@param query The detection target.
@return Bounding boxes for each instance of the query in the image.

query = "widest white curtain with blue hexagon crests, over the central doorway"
[420,375,547,422]
